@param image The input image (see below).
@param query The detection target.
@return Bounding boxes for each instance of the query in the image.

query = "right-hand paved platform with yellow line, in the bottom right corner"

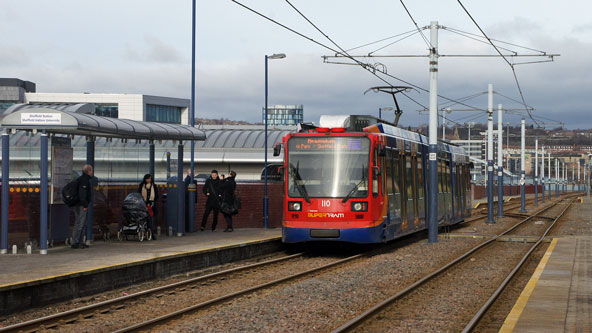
[500,236,592,332]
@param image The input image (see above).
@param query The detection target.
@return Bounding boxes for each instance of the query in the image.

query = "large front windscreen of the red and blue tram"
[288,136,370,200]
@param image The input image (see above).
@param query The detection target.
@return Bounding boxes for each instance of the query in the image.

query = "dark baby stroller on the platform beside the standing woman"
[117,193,152,242]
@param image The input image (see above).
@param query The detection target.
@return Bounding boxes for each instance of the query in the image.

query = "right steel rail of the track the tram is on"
[114,251,372,333]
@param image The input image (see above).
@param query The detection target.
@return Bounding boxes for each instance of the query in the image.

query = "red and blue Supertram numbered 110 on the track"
[282,115,471,243]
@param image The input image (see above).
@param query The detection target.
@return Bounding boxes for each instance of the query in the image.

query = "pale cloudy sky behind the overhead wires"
[0,0,592,129]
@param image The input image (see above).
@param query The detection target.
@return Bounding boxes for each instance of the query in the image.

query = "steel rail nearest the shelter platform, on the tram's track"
[0,253,304,332]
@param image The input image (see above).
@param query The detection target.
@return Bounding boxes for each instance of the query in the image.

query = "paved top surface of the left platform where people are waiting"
[0,228,282,289]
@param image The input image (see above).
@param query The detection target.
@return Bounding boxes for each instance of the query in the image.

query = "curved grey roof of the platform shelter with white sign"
[0,103,206,141]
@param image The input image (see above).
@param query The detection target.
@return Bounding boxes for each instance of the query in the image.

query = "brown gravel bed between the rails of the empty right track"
[355,242,530,332]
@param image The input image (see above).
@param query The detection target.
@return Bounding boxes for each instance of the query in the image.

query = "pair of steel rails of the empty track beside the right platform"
[333,196,573,333]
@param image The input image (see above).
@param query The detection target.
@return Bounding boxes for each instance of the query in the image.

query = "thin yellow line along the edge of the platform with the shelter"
[0,233,282,290]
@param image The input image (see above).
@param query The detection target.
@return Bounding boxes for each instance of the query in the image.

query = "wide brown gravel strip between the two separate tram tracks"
[162,239,482,332]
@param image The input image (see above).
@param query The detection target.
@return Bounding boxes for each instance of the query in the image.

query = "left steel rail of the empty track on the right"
[333,193,572,333]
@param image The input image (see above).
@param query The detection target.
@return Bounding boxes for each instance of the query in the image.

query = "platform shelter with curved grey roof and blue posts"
[0,104,206,254]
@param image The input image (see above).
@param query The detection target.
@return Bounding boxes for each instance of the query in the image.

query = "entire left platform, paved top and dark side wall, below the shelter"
[0,228,281,314]
